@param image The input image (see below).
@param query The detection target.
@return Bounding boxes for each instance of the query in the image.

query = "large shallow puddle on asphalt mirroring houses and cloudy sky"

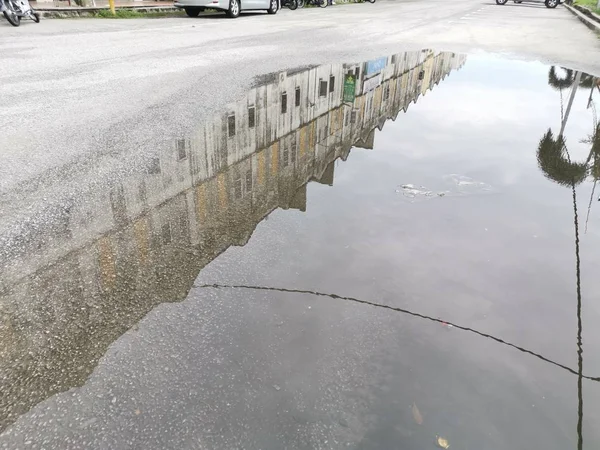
[0,50,600,450]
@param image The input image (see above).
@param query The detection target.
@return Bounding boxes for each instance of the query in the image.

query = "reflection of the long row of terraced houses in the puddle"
[0,51,465,430]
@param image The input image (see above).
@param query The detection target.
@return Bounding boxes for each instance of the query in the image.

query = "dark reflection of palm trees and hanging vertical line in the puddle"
[537,66,600,450]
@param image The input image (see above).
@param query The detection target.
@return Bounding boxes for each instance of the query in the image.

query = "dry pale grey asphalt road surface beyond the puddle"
[0,0,600,201]
